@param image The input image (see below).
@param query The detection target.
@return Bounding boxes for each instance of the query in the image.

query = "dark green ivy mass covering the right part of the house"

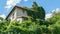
[27,2,45,21]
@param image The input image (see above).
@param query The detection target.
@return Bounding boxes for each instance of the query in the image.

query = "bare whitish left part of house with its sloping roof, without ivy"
[6,6,27,22]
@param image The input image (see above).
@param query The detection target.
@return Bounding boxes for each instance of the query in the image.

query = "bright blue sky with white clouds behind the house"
[0,0,60,18]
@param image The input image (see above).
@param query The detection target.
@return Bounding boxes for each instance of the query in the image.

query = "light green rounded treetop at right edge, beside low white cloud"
[47,11,60,24]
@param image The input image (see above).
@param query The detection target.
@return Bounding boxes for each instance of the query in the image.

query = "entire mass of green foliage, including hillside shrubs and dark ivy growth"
[0,2,60,34]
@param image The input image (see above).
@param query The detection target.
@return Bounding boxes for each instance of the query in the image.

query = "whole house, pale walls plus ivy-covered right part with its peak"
[6,2,45,22]
